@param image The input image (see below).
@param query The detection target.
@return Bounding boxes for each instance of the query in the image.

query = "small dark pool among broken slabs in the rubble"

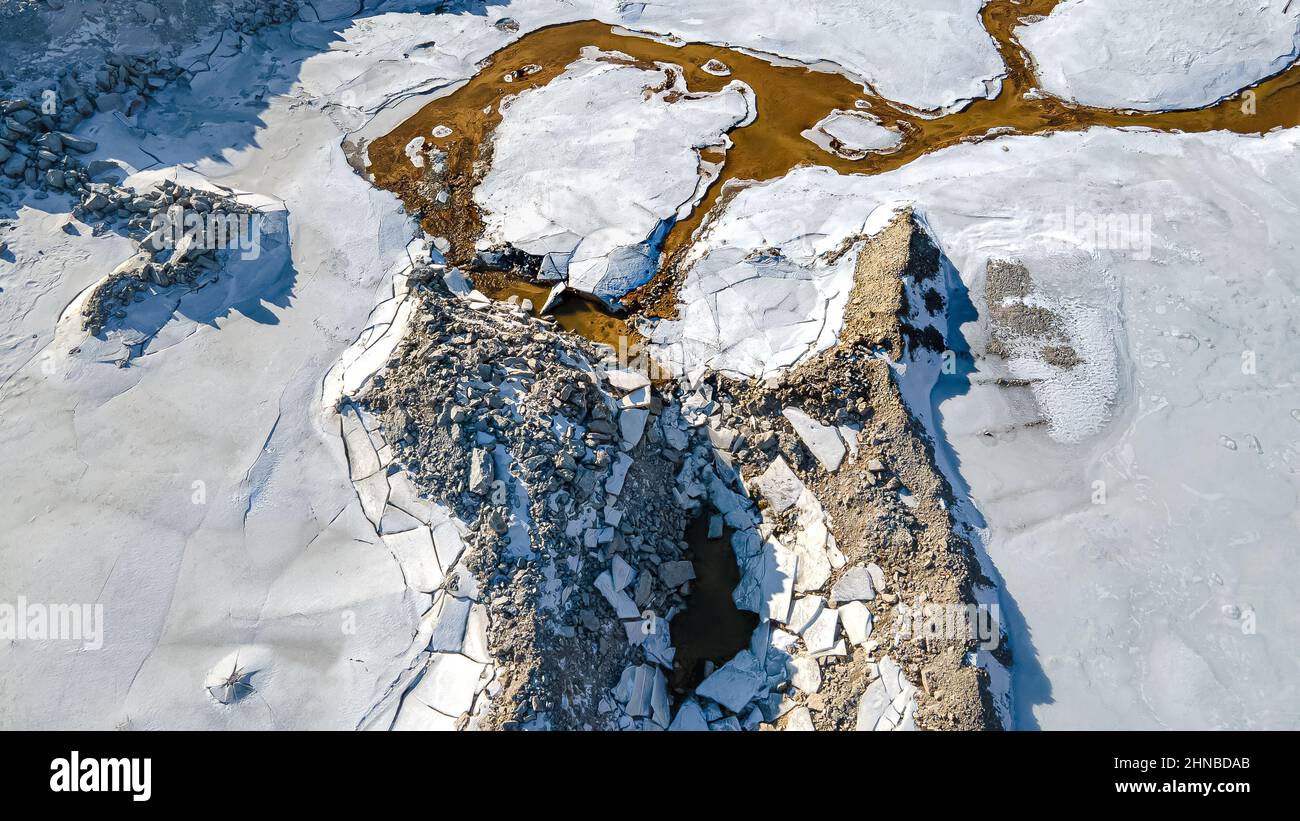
[668,516,758,690]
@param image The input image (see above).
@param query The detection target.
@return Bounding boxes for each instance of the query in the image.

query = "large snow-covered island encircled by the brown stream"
[475,48,755,307]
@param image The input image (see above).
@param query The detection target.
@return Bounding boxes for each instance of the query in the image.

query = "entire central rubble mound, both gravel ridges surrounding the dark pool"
[351,205,996,730]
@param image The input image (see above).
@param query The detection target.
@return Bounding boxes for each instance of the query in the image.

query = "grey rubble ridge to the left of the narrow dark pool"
[363,261,693,729]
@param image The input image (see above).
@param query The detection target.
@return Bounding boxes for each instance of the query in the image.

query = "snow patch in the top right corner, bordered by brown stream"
[1017,0,1300,110]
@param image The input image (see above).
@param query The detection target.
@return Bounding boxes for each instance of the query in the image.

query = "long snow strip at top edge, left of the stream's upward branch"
[361,0,1005,110]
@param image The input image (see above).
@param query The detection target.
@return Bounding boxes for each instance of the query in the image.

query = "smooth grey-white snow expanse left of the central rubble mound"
[0,16,429,729]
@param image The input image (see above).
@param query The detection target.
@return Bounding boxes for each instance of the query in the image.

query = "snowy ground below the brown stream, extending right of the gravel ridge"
[660,130,1300,727]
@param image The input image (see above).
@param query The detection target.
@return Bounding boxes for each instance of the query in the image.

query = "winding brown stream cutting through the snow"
[368,0,1300,342]
